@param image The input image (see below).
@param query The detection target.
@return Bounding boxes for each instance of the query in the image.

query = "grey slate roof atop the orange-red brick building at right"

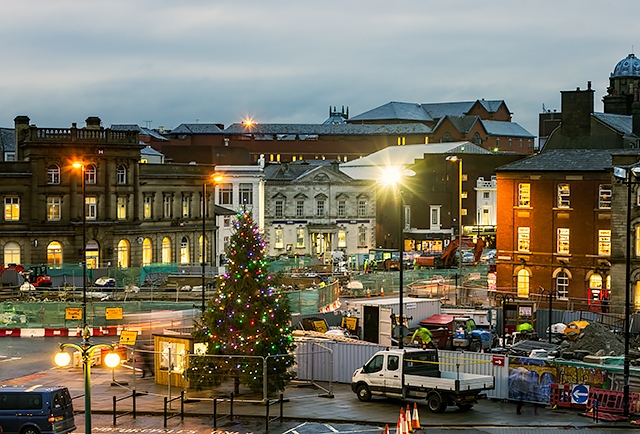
[496,149,620,172]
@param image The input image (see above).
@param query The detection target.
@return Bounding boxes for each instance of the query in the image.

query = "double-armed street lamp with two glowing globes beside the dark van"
[53,340,120,433]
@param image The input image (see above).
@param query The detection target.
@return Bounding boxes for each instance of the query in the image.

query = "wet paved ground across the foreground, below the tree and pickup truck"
[4,366,631,433]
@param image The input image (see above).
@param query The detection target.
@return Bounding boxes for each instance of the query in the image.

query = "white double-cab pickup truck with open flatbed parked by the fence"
[351,348,495,413]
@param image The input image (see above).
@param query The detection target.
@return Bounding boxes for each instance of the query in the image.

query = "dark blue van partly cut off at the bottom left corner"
[0,386,76,434]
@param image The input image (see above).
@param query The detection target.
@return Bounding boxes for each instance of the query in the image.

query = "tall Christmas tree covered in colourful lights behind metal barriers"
[187,210,294,393]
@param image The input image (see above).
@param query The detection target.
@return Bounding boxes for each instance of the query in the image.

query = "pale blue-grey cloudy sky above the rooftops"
[0,0,640,135]
